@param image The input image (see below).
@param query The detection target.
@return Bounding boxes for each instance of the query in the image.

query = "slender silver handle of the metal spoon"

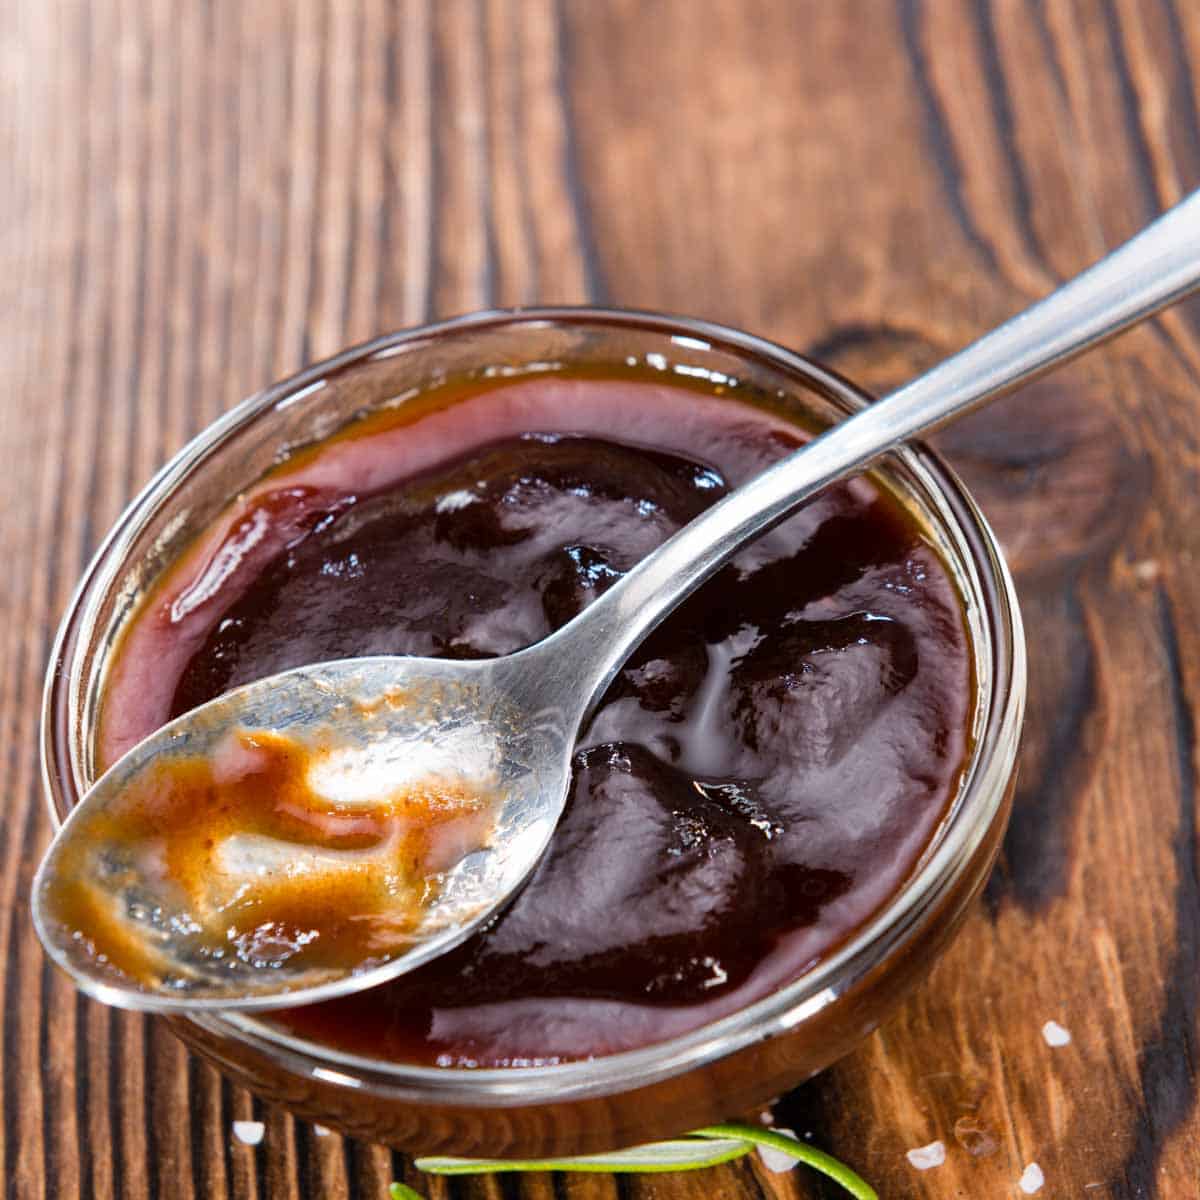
[556,192,1200,710]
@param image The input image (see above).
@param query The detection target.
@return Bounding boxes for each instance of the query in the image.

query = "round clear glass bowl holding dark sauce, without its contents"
[42,308,1025,1157]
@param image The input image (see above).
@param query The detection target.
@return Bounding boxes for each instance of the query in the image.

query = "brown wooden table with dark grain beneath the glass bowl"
[0,0,1200,1200]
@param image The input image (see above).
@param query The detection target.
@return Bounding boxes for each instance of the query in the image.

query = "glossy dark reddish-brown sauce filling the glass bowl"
[98,380,971,1066]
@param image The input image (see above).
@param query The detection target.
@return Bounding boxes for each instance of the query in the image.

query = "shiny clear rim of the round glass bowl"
[41,306,1026,1108]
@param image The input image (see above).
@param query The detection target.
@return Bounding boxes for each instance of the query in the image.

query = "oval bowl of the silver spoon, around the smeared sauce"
[34,655,574,1012]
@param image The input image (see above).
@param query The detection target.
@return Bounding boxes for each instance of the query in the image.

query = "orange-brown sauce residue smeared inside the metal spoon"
[48,714,494,988]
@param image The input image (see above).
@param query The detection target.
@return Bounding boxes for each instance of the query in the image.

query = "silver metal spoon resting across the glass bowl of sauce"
[32,193,1200,1012]
